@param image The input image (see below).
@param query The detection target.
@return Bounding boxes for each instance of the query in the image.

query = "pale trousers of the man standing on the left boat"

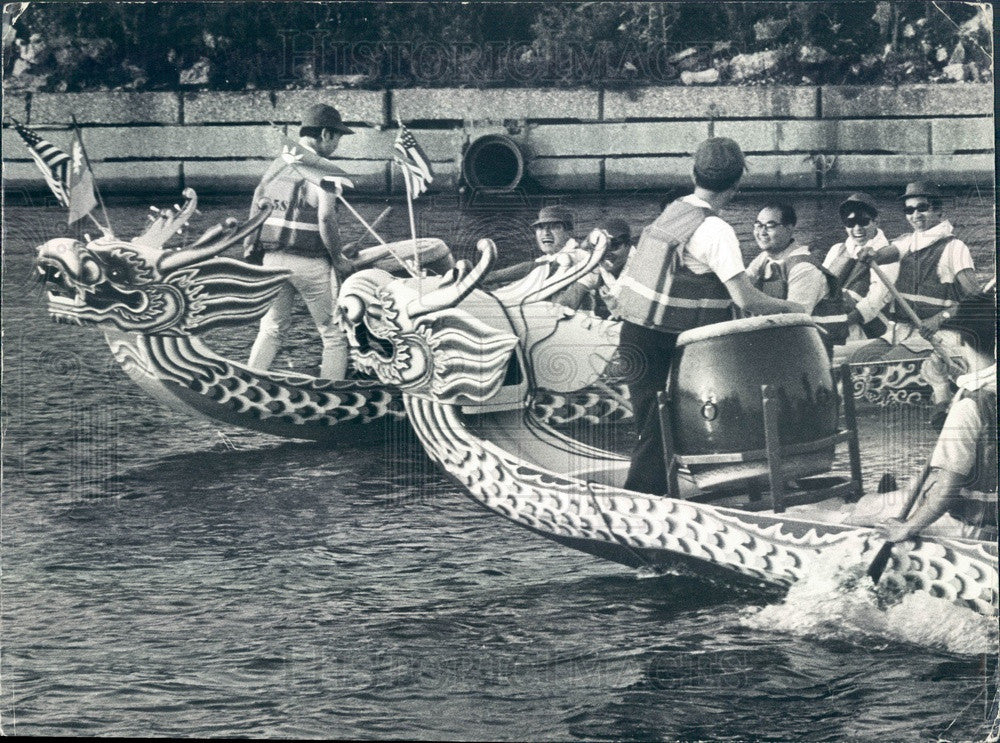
[247,251,347,379]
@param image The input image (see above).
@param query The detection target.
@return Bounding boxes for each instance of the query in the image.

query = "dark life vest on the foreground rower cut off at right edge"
[948,389,997,538]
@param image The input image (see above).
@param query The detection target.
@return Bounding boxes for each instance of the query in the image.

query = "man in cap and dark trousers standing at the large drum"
[614,137,803,494]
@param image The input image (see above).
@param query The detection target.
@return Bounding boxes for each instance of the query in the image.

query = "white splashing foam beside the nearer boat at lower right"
[740,539,998,655]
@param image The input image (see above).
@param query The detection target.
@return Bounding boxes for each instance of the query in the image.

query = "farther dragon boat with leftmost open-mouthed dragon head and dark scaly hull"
[36,189,631,442]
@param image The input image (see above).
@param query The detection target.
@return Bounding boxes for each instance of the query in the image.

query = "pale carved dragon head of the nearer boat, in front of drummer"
[338,231,618,409]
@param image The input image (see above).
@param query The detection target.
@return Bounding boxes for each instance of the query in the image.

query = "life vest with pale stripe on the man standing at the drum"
[613,199,733,333]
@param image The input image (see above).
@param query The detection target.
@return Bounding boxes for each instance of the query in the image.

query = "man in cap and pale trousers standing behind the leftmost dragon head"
[247,103,352,379]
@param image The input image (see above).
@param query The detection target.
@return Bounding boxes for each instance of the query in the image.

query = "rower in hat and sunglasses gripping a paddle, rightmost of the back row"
[871,181,980,422]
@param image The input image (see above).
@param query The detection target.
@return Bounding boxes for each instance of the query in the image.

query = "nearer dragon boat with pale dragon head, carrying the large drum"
[339,233,998,615]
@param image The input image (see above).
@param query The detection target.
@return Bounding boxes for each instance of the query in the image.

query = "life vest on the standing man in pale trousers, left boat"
[259,157,330,260]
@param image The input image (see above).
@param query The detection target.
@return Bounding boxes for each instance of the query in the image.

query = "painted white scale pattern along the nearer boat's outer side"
[404,396,998,615]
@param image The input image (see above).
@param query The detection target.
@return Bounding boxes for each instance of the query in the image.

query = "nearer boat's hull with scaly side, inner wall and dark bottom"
[404,396,998,615]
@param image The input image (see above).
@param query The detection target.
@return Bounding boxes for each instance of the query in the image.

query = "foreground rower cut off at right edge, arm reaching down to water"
[881,293,997,542]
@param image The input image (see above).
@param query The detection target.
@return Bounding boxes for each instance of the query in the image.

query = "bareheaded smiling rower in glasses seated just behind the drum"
[747,202,847,347]
